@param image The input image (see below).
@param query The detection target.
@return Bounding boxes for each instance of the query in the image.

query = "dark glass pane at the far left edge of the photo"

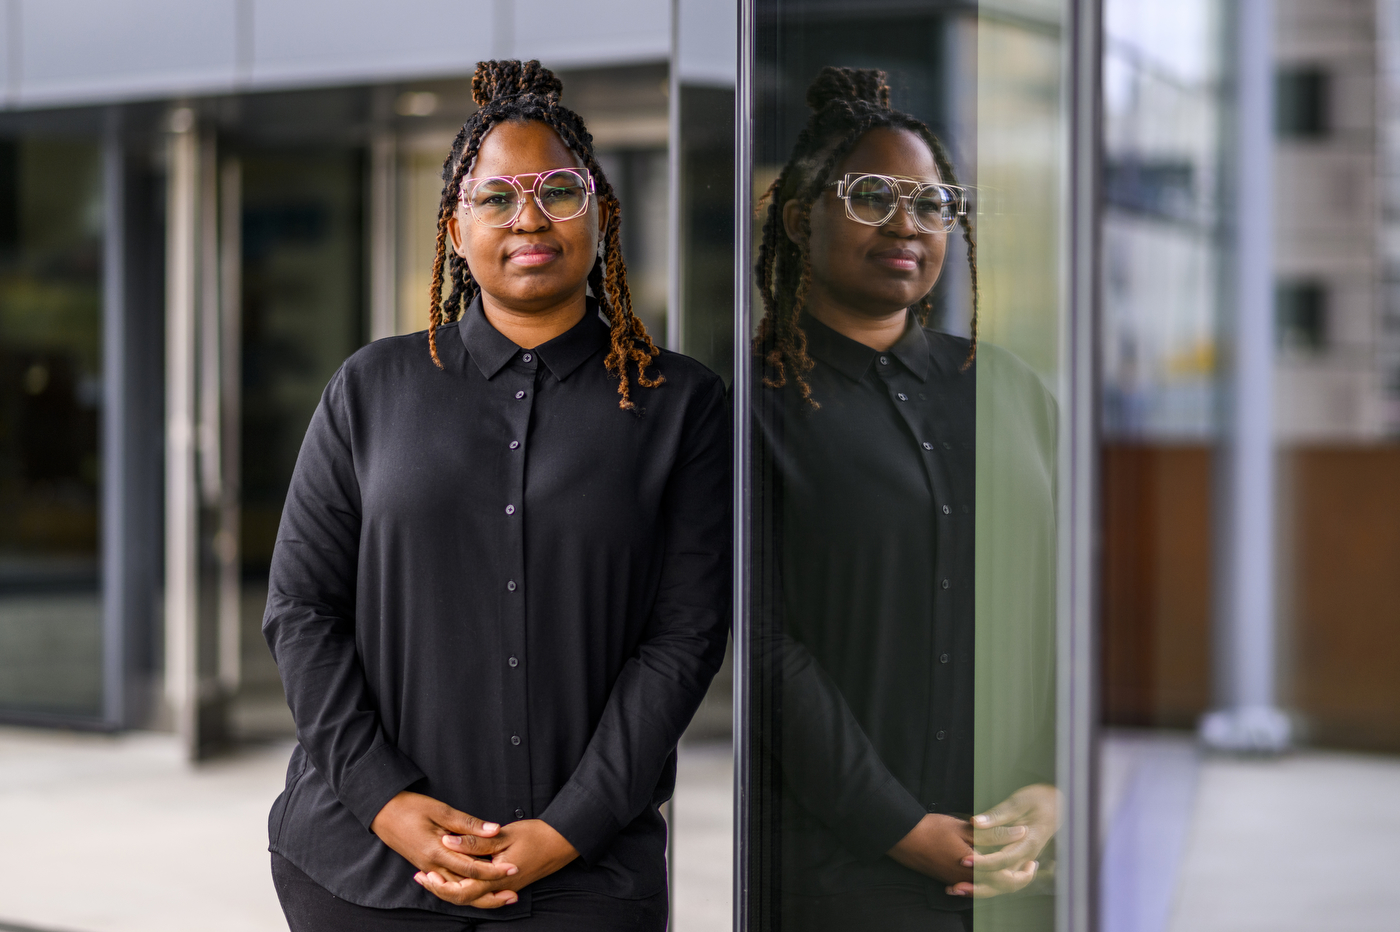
[0,137,102,718]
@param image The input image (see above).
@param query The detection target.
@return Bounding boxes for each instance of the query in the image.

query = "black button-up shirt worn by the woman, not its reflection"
[263,295,729,919]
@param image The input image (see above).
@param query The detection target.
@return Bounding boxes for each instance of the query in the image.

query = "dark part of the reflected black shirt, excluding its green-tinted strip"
[755,316,977,908]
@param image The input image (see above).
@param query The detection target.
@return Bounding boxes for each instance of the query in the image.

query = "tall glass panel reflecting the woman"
[739,0,1070,932]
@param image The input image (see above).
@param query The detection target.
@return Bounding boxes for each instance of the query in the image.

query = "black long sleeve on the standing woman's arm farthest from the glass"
[263,368,423,828]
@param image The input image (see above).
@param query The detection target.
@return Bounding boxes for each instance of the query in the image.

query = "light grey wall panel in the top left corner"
[10,0,238,106]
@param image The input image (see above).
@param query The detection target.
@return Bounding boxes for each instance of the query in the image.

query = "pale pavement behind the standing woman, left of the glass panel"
[0,728,731,932]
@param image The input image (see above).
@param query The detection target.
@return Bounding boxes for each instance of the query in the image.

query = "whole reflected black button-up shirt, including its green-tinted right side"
[750,310,1056,910]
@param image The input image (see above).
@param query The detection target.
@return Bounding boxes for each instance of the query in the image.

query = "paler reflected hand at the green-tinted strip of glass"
[948,784,1060,898]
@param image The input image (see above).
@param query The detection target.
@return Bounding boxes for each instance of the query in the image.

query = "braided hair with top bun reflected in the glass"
[753,66,977,409]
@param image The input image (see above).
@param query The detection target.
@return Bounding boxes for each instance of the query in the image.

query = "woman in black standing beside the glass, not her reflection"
[263,62,729,932]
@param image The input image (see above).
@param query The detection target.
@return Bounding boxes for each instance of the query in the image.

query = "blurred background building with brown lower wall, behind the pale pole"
[1100,0,1400,751]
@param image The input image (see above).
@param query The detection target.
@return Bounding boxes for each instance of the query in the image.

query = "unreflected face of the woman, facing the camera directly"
[448,122,606,312]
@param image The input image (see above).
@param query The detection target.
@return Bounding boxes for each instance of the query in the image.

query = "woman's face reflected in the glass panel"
[783,129,948,318]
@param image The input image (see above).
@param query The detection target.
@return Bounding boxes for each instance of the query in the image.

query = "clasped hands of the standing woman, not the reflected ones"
[370,791,578,910]
